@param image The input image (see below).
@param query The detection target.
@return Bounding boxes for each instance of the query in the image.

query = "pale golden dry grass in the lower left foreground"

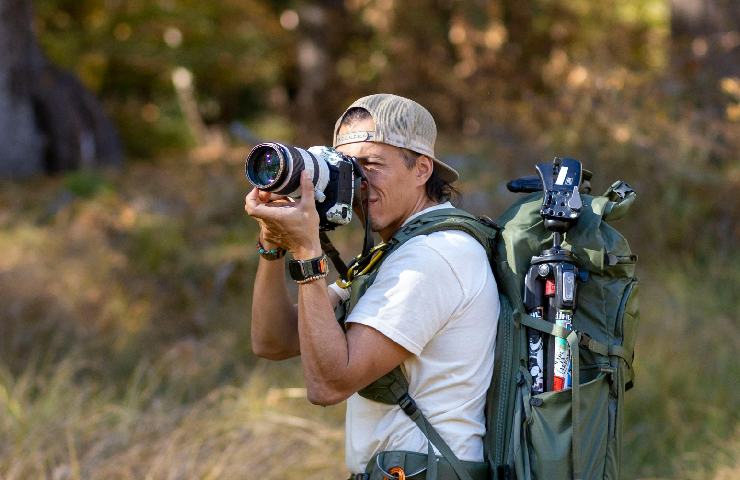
[0,356,343,480]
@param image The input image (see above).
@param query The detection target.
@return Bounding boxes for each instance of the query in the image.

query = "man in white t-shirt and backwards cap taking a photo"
[245,94,499,473]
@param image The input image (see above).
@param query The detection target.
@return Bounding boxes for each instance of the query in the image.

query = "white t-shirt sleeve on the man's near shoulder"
[347,236,463,355]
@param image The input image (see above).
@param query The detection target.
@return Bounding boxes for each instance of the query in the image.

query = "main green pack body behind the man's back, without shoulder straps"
[484,181,639,480]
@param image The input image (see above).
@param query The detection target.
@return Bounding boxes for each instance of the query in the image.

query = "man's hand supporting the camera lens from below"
[244,171,321,260]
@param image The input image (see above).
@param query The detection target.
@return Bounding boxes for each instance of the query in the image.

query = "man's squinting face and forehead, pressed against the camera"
[337,118,431,240]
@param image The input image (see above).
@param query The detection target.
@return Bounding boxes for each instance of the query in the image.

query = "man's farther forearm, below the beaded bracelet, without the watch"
[252,258,300,360]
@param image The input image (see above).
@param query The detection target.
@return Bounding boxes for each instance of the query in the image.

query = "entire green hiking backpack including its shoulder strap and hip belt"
[339,182,638,480]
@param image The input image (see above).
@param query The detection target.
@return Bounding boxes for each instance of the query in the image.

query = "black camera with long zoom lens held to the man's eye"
[244,142,362,231]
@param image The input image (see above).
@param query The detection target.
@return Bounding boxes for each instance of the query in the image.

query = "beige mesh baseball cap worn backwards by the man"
[333,93,459,183]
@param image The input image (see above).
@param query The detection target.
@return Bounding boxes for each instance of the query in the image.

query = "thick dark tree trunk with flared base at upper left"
[0,0,121,177]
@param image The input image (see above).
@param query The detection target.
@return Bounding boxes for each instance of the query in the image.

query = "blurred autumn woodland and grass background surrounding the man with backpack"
[0,0,740,480]
